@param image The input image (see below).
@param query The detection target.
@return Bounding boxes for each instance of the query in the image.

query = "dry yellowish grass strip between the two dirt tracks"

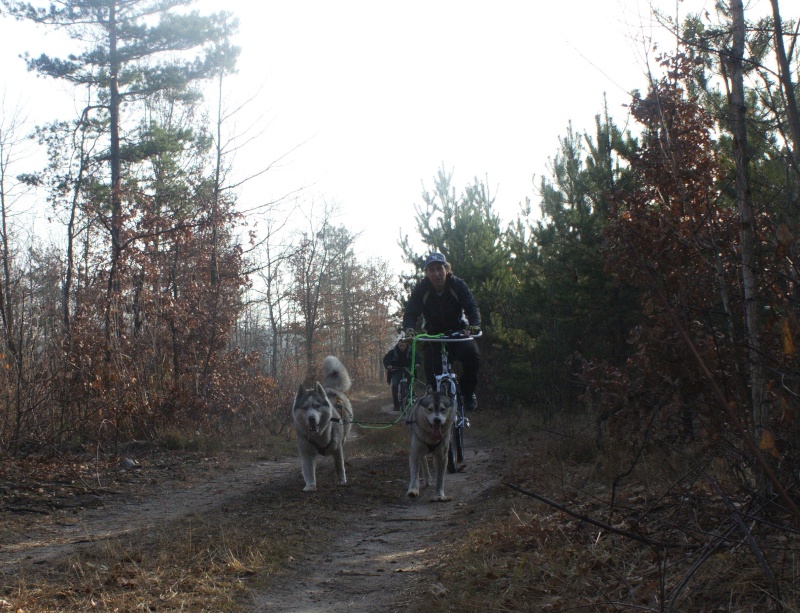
[0,456,325,612]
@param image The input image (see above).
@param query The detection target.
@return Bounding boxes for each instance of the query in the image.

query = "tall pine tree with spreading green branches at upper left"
[2,0,238,336]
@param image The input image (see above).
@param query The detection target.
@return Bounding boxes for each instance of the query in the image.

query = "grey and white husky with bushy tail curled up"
[292,355,353,492]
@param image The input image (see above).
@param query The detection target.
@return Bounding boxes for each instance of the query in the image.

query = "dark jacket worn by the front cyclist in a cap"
[403,273,481,334]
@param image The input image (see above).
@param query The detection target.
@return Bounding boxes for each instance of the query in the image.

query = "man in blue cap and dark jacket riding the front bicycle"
[403,251,481,411]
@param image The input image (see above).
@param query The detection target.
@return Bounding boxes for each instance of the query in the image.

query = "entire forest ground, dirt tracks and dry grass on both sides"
[0,387,788,613]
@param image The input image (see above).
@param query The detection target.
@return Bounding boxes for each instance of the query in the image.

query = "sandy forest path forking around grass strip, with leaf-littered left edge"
[0,398,500,613]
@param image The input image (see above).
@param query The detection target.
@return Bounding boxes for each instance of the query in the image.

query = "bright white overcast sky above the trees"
[0,0,784,271]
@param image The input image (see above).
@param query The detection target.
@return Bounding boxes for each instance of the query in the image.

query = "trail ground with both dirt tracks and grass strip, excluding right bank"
[0,390,502,613]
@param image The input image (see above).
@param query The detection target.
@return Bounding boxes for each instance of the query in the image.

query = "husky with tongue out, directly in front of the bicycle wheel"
[407,386,453,502]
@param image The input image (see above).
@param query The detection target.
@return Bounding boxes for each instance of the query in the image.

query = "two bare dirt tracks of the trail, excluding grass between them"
[0,402,498,613]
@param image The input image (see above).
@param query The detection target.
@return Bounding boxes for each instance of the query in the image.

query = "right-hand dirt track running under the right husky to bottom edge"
[250,420,496,613]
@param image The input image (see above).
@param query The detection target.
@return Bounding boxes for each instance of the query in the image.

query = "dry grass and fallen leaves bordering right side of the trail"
[418,406,800,613]
